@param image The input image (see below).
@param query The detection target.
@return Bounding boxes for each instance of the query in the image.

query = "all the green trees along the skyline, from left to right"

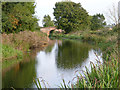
[2,1,106,33]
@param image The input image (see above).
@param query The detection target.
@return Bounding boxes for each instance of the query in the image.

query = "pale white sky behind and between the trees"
[35,0,120,26]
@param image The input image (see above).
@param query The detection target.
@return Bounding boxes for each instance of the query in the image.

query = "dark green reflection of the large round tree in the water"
[57,41,90,68]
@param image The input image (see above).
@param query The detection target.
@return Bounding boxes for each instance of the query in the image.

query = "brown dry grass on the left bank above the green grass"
[2,31,47,51]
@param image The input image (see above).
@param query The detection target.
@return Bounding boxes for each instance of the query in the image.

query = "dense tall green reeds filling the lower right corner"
[75,51,120,88]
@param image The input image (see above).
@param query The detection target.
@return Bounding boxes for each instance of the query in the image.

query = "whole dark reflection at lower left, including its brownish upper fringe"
[2,52,36,88]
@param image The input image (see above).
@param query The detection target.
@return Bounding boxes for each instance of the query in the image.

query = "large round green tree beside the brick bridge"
[53,1,90,33]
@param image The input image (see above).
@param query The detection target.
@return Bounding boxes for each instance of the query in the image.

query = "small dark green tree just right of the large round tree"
[90,14,106,30]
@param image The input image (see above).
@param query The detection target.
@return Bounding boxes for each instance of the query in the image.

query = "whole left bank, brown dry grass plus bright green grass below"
[0,31,47,69]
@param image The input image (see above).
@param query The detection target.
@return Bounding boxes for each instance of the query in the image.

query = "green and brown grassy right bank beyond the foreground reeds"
[51,28,118,58]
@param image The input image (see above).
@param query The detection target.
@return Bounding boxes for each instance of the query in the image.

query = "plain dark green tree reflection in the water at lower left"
[2,56,36,88]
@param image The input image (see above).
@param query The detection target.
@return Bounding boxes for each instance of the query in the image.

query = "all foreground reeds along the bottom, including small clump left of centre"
[34,48,120,89]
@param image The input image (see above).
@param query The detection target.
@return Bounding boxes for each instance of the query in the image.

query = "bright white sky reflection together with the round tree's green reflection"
[35,41,102,88]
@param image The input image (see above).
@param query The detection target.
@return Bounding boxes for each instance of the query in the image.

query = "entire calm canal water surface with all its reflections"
[2,40,102,88]
